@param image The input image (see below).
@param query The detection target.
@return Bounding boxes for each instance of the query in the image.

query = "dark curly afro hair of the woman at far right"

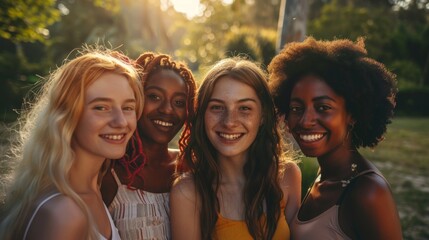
[268,37,397,148]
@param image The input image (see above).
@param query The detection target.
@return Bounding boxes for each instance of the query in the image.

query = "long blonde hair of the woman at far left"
[0,47,143,239]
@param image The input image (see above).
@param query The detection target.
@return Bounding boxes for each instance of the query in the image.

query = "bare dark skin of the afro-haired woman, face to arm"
[287,75,401,239]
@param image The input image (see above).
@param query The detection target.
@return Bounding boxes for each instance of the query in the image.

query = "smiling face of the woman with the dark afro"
[287,75,351,157]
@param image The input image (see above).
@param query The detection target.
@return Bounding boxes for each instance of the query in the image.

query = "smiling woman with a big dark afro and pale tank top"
[268,37,402,240]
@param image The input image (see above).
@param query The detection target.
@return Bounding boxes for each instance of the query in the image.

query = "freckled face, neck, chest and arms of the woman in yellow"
[170,77,301,240]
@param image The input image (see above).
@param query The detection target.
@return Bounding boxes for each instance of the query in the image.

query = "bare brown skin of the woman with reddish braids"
[102,69,187,205]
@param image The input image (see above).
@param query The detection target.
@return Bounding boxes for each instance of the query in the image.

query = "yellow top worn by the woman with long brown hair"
[213,201,290,240]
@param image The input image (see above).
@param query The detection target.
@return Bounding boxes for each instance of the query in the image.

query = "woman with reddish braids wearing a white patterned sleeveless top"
[102,52,196,239]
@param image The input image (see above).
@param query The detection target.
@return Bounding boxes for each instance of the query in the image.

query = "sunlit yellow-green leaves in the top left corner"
[0,0,60,43]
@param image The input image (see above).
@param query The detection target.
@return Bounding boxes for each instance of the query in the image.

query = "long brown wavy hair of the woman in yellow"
[179,58,285,239]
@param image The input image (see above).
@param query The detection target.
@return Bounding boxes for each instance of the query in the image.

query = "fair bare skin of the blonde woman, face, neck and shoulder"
[27,73,137,240]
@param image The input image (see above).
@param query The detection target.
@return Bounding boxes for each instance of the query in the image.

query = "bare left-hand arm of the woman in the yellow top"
[170,174,201,240]
